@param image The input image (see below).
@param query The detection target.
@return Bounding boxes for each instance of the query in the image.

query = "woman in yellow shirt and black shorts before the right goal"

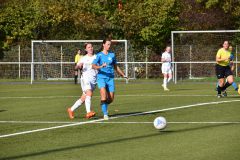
[216,41,233,98]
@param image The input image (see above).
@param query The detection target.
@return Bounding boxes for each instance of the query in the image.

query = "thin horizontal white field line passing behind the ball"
[0,121,240,124]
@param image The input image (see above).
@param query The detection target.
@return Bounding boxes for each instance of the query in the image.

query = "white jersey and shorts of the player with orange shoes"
[78,55,97,84]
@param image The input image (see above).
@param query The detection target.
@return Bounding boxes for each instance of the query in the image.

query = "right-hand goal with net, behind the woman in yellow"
[171,30,240,83]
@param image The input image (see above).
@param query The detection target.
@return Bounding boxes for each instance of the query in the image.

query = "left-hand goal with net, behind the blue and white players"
[31,40,132,83]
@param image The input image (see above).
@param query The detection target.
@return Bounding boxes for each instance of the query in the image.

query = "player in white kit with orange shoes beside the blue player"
[67,43,97,119]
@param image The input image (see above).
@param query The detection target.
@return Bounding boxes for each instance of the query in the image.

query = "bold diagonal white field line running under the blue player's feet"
[0,100,240,138]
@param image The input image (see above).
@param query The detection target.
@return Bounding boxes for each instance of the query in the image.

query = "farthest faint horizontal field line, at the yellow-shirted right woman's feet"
[0,94,239,99]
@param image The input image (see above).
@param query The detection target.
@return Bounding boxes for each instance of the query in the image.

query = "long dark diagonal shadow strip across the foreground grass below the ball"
[0,124,236,160]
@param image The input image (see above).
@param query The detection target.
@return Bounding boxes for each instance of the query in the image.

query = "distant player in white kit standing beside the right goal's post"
[161,46,172,91]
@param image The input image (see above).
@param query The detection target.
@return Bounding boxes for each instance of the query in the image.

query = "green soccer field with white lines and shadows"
[0,79,240,160]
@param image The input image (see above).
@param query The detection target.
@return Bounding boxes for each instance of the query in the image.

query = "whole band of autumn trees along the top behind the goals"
[0,0,240,57]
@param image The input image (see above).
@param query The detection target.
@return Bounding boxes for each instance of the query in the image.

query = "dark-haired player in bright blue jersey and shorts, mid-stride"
[92,39,127,120]
